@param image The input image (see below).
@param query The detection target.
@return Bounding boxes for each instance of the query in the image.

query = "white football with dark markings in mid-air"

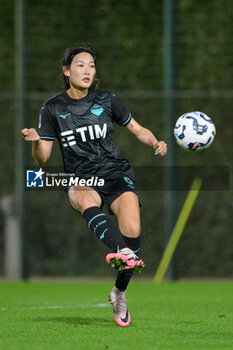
[174,112,216,151]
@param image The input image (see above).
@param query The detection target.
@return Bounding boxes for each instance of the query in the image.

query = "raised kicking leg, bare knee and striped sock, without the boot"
[68,186,132,251]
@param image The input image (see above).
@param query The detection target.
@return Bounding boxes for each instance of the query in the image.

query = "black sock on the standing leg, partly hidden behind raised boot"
[115,235,140,292]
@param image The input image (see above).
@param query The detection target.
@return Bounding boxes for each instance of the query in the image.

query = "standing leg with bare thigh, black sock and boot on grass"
[109,192,141,327]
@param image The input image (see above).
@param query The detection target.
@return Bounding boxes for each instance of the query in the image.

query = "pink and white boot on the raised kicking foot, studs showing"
[106,248,145,273]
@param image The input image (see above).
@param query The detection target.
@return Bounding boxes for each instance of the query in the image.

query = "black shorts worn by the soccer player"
[68,176,141,215]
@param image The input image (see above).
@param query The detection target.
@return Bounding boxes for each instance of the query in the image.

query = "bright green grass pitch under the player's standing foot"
[0,281,233,350]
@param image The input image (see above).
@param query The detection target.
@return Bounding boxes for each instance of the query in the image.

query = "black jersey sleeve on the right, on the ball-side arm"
[111,94,132,125]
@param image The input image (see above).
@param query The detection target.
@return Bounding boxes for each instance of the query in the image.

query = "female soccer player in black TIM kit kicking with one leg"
[21,47,167,327]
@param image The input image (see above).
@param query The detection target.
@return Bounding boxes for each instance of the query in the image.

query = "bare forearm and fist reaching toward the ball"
[126,118,167,156]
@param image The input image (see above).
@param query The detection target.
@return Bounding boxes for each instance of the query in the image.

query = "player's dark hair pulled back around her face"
[62,46,99,90]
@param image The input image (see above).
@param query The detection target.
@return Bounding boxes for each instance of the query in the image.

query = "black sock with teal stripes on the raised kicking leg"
[83,207,128,251]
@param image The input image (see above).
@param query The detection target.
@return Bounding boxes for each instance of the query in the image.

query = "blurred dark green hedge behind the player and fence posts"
[0,0,233,278]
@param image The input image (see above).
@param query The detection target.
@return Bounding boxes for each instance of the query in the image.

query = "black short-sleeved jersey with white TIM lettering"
[38,89,133,179]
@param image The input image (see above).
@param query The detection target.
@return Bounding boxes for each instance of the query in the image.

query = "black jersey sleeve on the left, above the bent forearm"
[38,104,57,140]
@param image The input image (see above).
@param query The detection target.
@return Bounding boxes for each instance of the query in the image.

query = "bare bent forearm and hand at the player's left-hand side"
[21,128,53,166]
